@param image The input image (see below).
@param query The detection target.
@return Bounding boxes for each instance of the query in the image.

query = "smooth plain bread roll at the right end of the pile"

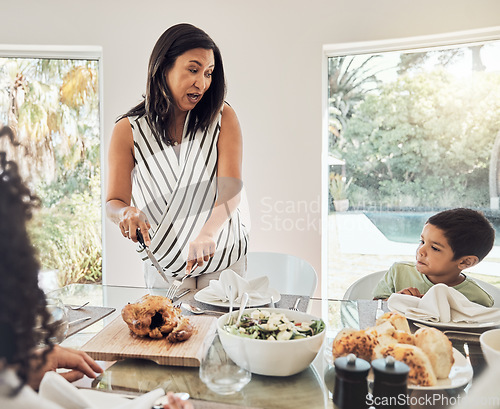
[415,328,455,379]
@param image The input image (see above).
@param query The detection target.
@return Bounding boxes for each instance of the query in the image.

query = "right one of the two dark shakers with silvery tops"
[372,356,410,409]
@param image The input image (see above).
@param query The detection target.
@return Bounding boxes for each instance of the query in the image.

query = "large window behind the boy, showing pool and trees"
[323,30,500,298]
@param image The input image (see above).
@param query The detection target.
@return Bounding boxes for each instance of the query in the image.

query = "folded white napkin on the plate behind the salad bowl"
[203,269,271,305]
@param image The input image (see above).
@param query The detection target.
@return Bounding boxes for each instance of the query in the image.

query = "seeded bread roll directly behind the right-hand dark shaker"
[380,344,437,386]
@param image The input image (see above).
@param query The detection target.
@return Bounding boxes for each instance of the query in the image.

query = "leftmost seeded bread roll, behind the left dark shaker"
[332,328,378,362]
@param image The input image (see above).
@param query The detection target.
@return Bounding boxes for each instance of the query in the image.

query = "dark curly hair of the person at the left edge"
[0,127,53,395]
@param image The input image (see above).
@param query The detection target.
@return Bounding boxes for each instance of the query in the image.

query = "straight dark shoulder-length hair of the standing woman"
[118,23,226,145]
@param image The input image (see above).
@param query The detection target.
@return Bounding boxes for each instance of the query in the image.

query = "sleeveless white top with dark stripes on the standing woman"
[129,113,248,277]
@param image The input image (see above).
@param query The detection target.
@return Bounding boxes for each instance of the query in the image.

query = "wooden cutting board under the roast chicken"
[82,316,217,366]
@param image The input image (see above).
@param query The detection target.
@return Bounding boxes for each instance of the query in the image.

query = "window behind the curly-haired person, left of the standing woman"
[0,46,102,286]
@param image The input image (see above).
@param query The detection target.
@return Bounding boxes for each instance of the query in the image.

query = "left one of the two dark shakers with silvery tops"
[333,354,370,409]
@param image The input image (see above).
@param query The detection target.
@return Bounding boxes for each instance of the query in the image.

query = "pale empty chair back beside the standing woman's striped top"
[246,251,318,297]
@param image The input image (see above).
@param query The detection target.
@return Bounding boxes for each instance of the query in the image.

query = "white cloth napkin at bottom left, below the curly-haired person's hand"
[39,372,165,409]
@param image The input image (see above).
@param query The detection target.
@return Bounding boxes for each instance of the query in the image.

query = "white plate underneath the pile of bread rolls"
[325,340,474,390]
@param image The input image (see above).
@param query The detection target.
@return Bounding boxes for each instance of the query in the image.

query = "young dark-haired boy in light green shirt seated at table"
[373,208,495,307]
